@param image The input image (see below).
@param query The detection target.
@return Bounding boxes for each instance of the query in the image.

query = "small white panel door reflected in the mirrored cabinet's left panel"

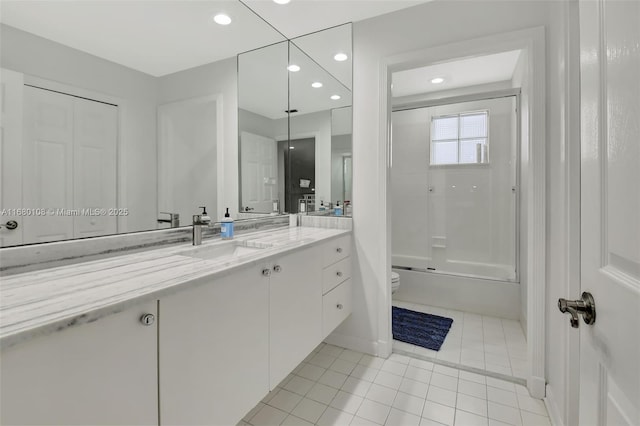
[240,132,278,212]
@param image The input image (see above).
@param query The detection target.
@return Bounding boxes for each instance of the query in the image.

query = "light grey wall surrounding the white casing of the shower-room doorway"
[331,1,566,420]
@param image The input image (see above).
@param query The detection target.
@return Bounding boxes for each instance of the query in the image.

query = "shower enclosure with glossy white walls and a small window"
[391,95,520,282]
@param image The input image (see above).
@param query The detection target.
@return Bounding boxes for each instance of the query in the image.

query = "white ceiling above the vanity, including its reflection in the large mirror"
[0,0,426,77]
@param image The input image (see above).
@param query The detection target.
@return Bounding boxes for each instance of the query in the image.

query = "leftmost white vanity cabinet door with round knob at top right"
[0,301,158,425]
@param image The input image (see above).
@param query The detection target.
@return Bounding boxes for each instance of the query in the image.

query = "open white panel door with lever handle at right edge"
[579,0,640,425]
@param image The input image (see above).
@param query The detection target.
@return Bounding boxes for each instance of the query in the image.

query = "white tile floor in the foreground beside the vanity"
[238,343,550,426]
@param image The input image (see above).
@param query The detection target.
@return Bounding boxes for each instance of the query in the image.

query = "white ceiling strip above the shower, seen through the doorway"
[391,50,520,97]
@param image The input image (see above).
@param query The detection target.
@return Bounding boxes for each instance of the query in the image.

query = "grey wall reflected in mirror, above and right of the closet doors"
[0,24,157,231]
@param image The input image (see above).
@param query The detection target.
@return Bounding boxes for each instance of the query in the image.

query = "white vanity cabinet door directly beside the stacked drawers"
[269,247,322,389]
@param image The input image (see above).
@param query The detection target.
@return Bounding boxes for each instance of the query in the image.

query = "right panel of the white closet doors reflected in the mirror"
[73,98,118,238]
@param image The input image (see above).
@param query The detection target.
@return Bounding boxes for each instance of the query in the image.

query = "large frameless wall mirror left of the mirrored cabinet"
[0,0,286,247]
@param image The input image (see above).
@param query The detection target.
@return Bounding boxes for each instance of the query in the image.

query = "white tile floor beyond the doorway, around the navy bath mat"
[393,300,528,378]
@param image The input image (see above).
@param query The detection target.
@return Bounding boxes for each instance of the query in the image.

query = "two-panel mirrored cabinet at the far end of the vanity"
[238,24,352,215]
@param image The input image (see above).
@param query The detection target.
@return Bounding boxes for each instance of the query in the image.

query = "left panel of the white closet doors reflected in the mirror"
[22,86,74,243]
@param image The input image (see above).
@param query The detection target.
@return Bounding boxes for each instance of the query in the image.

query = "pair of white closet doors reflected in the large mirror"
[21,86,118,243]
